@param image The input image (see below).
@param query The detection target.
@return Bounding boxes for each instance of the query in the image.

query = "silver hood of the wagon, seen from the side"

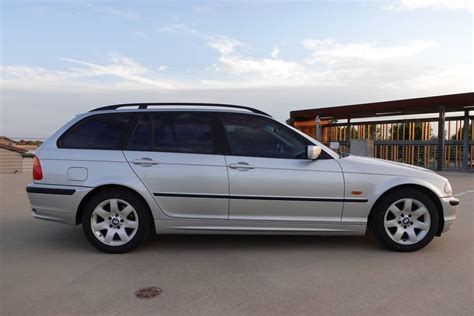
[338,156,443,179]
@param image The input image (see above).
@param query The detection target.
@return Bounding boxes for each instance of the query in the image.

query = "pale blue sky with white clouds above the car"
[0,0,474,138]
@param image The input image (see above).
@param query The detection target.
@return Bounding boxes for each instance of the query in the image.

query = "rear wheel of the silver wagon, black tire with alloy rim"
[82,188,153,253]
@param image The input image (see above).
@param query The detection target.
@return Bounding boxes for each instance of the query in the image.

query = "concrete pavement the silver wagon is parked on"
[0,173,474,315]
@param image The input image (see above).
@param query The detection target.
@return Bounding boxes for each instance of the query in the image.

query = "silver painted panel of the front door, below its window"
[226,156,344,223]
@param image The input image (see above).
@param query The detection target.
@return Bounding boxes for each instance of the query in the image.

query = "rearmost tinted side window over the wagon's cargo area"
[58,113,132,149]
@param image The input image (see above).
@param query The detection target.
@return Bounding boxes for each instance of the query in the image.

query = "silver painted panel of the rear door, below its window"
[124,151,229,219]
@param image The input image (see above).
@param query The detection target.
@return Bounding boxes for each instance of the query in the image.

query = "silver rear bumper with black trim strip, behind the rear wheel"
[26,183,92,225]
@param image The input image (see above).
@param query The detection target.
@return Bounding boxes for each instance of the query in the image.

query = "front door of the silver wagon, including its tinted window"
[222,114,344,223]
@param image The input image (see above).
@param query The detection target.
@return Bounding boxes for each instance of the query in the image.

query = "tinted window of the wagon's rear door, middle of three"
[128,112,217,154]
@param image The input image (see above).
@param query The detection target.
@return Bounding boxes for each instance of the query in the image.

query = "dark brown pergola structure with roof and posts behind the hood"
[290,92,474,170]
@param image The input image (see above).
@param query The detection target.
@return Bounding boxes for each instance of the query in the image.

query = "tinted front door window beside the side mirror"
[222,114,307,159]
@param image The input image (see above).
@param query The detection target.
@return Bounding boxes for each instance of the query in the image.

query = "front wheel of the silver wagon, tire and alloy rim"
[369,188,439,252]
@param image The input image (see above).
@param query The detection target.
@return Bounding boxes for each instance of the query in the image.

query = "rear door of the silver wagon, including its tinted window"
[124,111,229,219]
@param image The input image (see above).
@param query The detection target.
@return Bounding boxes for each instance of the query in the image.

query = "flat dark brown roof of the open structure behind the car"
[290,92,474,120]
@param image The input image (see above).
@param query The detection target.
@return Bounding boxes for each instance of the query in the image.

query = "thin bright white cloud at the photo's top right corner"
[387,0,474,13]
